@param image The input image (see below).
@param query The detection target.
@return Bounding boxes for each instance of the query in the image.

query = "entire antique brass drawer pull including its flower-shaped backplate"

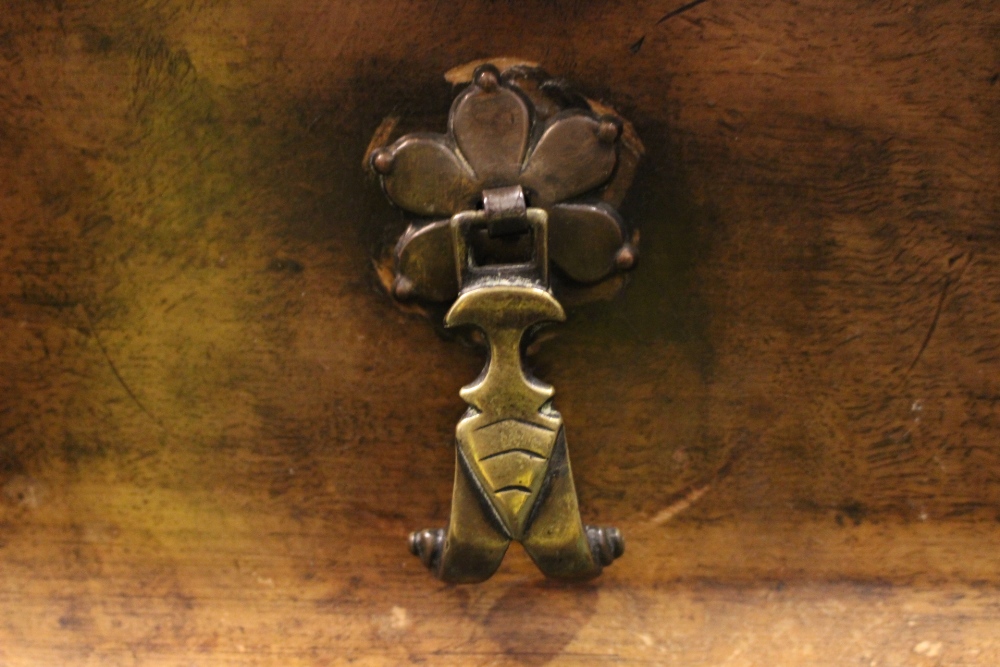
[370,64,642,583]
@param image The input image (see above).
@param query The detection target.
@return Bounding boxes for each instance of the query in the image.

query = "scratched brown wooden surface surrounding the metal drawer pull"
[0,0,1000,667]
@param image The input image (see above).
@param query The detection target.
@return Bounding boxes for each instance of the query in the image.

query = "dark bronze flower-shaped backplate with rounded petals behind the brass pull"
[370,64,642,301]
